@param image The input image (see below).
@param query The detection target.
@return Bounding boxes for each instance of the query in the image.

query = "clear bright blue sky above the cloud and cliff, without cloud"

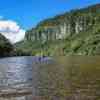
[0,0,100,29]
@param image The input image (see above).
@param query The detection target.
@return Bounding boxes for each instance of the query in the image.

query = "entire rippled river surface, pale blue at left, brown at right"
[0,56,100,100]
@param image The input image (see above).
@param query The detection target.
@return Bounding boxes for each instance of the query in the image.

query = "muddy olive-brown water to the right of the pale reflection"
[32,56,100,100]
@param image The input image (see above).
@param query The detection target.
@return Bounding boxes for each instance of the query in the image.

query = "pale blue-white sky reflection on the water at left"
[0,57,32,88]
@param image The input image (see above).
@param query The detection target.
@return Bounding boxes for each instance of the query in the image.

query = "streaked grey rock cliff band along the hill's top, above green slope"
[25,5,100,41]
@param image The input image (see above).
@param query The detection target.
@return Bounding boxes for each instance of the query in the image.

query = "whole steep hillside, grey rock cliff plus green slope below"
[16,4,100,55]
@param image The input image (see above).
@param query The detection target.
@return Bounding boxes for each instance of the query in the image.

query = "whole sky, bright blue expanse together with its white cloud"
[0,0,100,43]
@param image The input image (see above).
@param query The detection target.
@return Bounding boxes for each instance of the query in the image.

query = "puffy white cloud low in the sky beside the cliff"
[0,20,25,43]
